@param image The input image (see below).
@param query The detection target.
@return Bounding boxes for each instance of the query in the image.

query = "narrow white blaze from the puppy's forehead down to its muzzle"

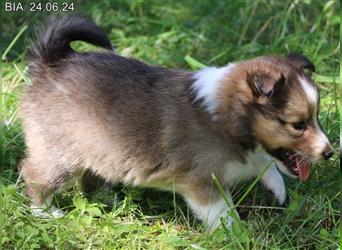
[299,77,330,155]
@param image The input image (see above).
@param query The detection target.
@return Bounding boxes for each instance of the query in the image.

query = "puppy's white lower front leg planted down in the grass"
[185,188,239,231]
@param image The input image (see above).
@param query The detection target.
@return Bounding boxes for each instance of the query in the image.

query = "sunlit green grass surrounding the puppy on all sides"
[0,0,341,249]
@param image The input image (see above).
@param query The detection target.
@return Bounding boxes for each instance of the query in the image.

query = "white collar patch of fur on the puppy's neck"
[192,63,235,120]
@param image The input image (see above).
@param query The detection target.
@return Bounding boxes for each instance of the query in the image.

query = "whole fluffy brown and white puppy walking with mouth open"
[20,16,332,229]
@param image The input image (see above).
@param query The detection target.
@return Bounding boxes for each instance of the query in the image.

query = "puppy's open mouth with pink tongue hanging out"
[270,148,310,181]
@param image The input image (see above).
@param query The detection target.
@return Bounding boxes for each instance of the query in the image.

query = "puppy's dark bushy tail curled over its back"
[28,15,113,65]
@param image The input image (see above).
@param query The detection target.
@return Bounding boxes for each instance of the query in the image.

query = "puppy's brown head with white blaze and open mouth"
[246,54,333,180]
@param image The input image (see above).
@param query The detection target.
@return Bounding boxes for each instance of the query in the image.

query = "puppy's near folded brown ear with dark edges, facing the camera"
[247,71,285,98]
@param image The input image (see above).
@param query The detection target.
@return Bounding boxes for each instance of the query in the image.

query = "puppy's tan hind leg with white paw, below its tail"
[22,158,79,218]
